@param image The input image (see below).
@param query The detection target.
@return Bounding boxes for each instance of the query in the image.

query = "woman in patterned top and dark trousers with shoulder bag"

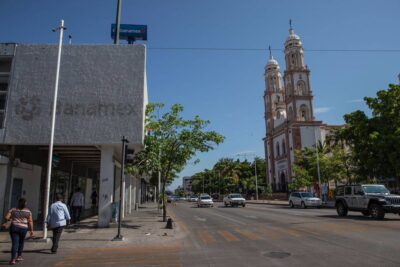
[5,198,33,265]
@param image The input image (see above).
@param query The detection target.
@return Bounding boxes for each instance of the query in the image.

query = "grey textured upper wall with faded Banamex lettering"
[0,45,147,148]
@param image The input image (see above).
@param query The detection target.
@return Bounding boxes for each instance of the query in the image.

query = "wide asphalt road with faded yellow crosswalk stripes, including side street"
[5,202,400,267]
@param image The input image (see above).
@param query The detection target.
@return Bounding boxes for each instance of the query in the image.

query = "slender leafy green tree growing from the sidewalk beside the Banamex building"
[132,103,224,221]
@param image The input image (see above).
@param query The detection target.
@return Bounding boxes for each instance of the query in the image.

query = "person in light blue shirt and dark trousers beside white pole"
[47,194,71,254]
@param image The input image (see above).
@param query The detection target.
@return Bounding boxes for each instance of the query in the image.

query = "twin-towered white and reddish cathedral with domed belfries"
[263,25,334,192]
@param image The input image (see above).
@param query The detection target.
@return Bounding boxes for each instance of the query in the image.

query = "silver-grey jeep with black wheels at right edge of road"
[335,184,400,220]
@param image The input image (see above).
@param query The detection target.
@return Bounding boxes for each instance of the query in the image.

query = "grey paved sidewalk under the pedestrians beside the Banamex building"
[0,203,182,253]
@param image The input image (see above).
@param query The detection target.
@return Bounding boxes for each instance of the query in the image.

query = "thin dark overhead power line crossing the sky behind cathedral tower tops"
[148,47,400,53]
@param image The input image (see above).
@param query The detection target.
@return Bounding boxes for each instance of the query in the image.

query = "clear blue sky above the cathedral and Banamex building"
[0,0,400,189]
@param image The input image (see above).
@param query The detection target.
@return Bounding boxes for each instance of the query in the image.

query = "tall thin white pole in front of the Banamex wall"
[43,20,66,240]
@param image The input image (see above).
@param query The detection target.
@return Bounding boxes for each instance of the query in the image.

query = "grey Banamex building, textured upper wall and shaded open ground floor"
[0,44,147,227]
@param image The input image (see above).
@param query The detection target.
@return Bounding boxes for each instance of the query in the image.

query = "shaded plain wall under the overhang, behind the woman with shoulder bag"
[10,162,42,220]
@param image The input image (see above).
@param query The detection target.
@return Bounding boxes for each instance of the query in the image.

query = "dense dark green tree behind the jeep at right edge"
[340,84,400,181]
